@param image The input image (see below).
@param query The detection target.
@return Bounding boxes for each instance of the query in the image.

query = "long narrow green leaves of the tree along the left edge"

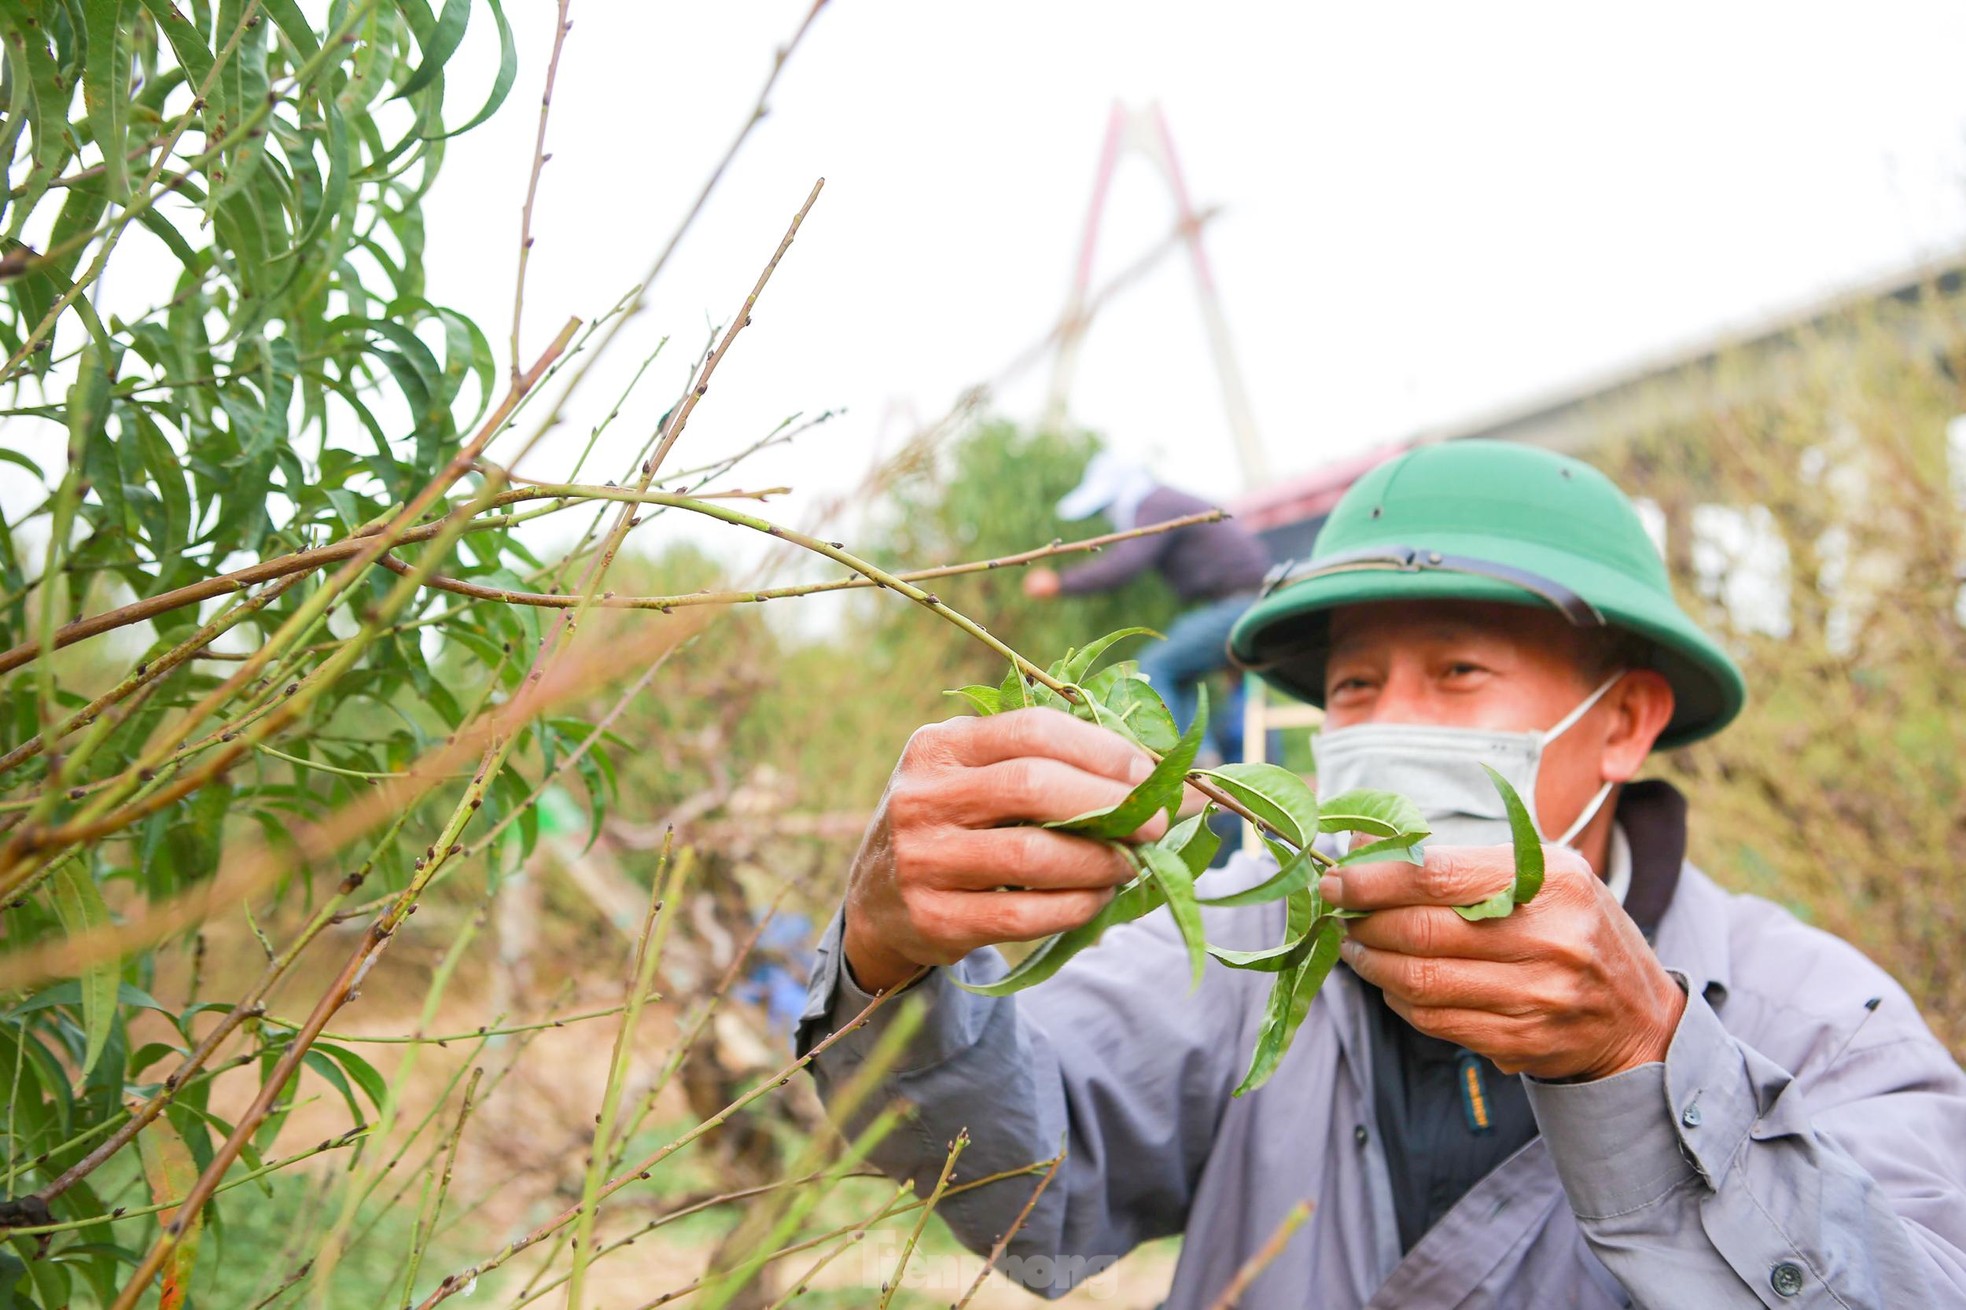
[0,0,615,1306]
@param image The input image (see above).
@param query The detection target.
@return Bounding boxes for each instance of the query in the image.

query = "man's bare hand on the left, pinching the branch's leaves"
[845,710,1166,991]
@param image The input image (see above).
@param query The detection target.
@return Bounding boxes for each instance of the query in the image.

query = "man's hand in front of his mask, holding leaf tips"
[1321,846,1687,1080]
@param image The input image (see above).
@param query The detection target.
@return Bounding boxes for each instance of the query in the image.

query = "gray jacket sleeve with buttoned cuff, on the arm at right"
[1526,980,1966,1310]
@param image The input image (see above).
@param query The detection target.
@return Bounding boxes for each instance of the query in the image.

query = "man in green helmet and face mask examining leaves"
[800,441,1966,1310]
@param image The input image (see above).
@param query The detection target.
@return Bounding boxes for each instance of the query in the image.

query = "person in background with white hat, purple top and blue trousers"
[1024,450,1270,759]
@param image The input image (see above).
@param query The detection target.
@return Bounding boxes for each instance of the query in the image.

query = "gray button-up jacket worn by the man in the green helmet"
[798,856,1966,1310]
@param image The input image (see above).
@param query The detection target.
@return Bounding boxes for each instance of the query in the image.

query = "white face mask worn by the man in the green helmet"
[1311,673,1624,846]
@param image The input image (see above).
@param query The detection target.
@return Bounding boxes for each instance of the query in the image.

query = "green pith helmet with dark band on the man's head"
[1229,441,1748,747]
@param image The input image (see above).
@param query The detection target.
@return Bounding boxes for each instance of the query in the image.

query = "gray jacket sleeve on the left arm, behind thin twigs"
[796,889,1270,1296]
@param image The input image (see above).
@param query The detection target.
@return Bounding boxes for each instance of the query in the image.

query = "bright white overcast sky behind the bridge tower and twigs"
[427,0,1966,531]
